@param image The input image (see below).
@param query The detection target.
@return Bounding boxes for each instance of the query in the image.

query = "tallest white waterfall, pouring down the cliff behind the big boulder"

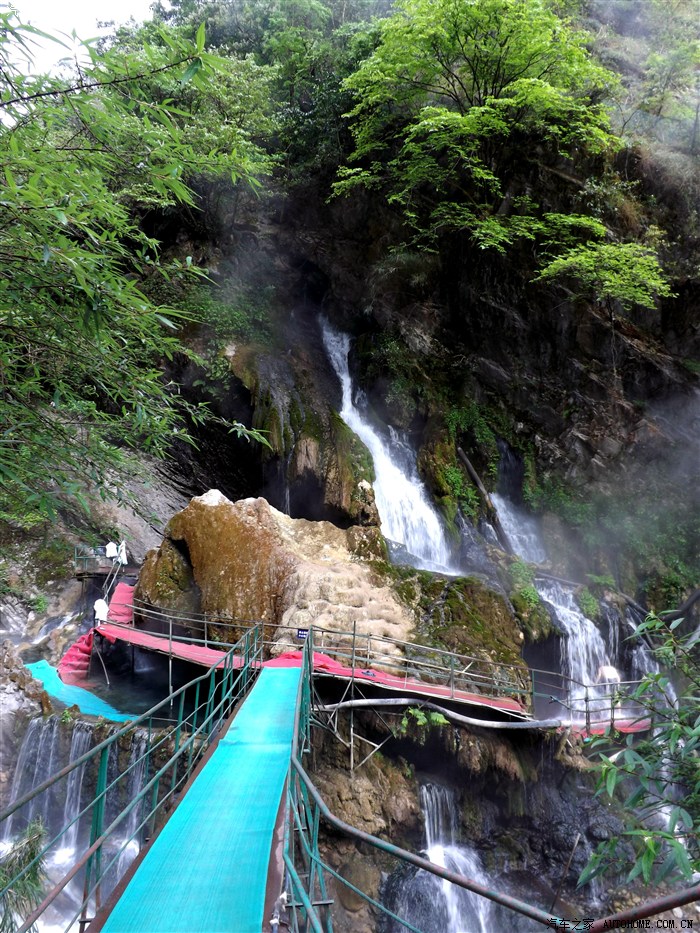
[322,321,460,574]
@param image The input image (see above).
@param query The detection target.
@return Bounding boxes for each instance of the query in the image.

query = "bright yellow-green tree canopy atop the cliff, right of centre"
[335,0,663,314]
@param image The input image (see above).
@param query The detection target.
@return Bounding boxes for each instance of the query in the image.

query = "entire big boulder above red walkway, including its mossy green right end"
[134,490,527,675]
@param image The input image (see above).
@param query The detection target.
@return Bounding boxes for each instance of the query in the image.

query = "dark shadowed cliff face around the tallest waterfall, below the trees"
[167,179,698,596]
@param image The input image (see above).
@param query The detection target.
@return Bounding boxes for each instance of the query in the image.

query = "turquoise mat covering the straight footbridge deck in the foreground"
[102,668,301,933]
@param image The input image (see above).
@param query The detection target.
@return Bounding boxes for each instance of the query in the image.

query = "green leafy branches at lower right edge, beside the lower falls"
[579,612,700,884]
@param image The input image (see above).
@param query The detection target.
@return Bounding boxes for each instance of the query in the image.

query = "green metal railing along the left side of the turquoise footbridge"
[0,626,262,933]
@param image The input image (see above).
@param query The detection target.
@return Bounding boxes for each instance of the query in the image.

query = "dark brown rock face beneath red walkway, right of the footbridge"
[313,711,621,933]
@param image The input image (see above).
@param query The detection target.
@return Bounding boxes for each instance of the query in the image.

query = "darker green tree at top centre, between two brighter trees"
[156,0,389,186]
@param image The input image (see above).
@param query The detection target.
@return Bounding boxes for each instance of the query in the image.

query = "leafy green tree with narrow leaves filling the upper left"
[0,13,268,512]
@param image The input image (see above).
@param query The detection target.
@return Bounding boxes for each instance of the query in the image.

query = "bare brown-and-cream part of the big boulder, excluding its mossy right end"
[135,490,413,640]
